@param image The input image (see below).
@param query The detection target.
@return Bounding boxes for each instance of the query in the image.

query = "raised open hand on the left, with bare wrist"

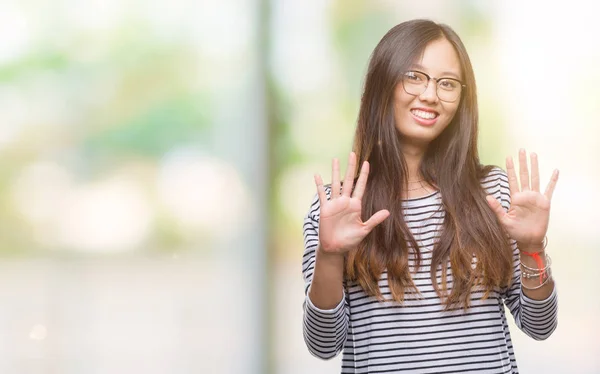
[315,152,390,253]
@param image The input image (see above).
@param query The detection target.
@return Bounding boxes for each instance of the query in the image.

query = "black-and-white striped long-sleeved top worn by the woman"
[302,168,557,374]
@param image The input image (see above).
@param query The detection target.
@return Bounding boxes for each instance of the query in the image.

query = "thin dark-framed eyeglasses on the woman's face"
[402,70,467,103]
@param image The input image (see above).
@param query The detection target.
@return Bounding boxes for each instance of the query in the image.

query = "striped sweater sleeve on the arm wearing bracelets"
[484,168,558,340]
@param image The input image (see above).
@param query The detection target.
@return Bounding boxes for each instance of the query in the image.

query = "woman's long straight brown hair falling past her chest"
[346,20,513,308]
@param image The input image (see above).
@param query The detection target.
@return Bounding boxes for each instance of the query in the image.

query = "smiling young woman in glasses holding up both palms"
[303,20,558,373]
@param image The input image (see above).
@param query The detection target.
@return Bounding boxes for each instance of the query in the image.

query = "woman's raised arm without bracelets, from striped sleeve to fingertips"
[302,152,390,358]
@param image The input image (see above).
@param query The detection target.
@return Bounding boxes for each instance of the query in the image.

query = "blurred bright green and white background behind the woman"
[0,0,600,374]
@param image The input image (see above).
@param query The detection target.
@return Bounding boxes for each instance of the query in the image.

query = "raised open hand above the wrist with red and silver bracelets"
[487,149,558,251]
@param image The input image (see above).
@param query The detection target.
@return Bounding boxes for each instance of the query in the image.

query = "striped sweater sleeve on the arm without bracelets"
[302,188,349,359]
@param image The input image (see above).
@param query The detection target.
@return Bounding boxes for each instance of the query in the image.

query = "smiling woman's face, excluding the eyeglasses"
[394,39,462,147]
